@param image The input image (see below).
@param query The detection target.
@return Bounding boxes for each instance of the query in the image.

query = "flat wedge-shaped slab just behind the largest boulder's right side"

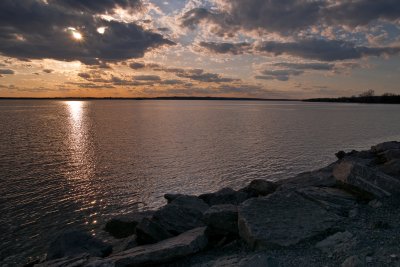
[297,186,357,216]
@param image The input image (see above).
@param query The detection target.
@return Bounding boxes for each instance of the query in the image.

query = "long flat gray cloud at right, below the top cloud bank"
[256,39,400,61]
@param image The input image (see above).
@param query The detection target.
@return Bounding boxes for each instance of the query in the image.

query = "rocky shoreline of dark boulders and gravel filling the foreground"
[26,141,400,267]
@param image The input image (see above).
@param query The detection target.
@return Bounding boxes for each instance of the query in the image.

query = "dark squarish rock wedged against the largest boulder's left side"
[203,204,238,235]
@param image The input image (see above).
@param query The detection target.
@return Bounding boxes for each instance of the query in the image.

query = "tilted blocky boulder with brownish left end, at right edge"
[333,160,400,198]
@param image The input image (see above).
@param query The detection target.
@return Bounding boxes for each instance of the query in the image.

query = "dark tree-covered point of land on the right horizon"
[304,90,400,104]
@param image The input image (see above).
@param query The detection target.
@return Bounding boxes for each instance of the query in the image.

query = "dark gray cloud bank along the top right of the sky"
[181,0,400,35]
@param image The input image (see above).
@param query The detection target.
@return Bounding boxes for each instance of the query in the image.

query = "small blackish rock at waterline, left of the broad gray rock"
[104,211,154,239]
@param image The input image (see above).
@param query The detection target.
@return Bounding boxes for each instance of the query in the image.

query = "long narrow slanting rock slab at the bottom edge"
[104,227,207,267]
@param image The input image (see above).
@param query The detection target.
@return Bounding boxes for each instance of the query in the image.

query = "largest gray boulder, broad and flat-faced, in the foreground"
[238,192,342,248]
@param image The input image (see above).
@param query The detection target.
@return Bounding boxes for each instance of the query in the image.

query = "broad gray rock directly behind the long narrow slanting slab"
[152,196,209,235]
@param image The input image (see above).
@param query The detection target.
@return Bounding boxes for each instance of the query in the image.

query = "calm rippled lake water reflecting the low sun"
[0,100,400,263]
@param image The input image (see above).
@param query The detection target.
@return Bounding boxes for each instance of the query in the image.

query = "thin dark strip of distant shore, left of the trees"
[0,97,302,101]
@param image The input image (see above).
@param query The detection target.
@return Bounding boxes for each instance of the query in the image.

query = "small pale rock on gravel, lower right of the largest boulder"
[315,231,355,253]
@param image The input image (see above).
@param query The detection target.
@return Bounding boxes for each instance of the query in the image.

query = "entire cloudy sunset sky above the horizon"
[0,0,400,99]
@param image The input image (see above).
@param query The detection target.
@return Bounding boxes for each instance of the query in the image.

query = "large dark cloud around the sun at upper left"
[0,0,174,65]
